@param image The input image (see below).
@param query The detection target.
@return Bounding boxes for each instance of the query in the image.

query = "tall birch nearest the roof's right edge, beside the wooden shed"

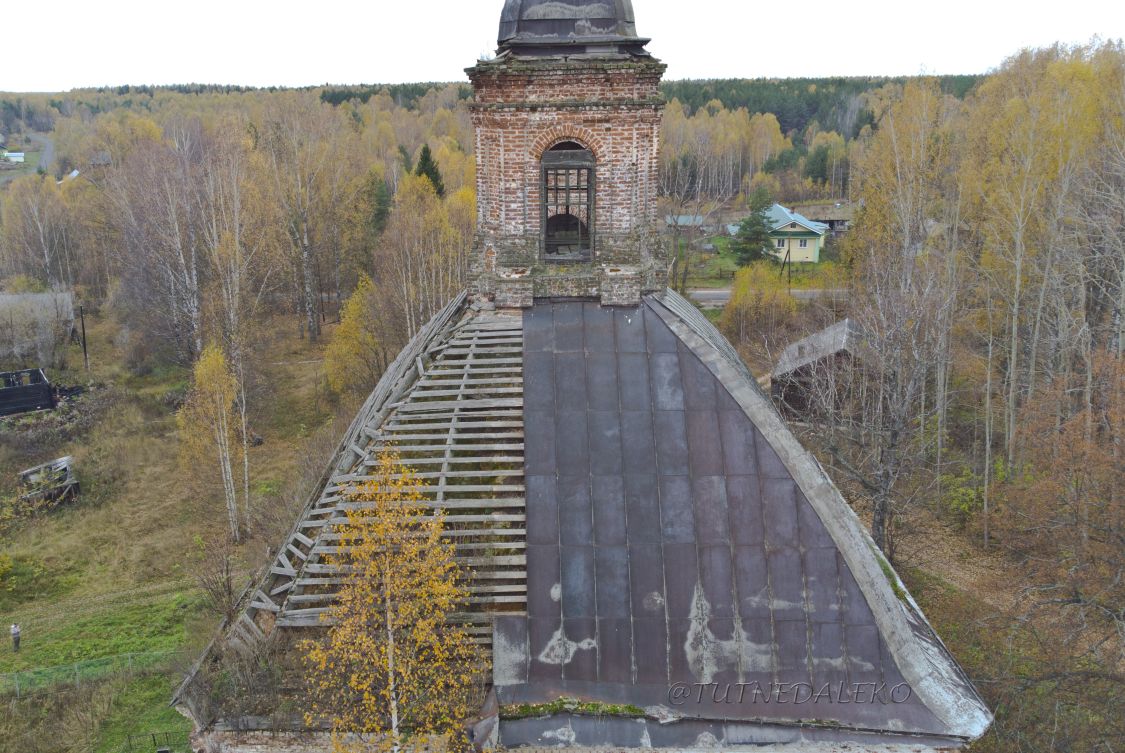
[837,81,955,556]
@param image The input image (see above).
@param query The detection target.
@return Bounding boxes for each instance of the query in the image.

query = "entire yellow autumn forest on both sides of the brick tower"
[0,44,1125,753]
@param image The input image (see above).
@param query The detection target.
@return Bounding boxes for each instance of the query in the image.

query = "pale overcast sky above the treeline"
[0,0,1125,91]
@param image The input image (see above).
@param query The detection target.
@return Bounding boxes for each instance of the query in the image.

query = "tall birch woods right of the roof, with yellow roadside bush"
[722,44,1125,751]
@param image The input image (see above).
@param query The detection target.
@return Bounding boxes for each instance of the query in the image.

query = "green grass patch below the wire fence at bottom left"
[93,674,191,753]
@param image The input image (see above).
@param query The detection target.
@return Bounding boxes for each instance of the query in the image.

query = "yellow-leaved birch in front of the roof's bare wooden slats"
[304,450,483,751]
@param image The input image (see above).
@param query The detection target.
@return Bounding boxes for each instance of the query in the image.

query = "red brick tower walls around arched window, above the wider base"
[469,61,664,236]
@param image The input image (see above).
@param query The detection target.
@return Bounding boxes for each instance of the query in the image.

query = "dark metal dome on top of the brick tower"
[498,0,648,55]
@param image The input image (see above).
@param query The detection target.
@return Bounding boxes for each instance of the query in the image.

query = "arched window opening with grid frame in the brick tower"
[541,141,594,261]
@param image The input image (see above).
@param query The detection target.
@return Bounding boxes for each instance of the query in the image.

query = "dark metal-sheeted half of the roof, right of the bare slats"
[494,293,988,747]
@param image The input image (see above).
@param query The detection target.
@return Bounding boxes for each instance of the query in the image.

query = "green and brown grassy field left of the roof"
[0,314,338,753]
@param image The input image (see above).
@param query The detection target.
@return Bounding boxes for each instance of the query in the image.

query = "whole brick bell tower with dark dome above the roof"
[467,0,669,307]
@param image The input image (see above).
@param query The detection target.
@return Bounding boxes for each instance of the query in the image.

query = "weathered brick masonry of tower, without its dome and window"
[468,55,668,306]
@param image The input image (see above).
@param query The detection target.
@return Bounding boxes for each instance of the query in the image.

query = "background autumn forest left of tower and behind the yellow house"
[0,71,901,367]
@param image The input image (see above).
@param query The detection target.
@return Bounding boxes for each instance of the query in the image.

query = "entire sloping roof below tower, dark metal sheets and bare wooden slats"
[189,290,991,751]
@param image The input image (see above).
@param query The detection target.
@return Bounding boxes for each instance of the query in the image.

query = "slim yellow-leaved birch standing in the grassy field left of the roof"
[176,344,242,541]
